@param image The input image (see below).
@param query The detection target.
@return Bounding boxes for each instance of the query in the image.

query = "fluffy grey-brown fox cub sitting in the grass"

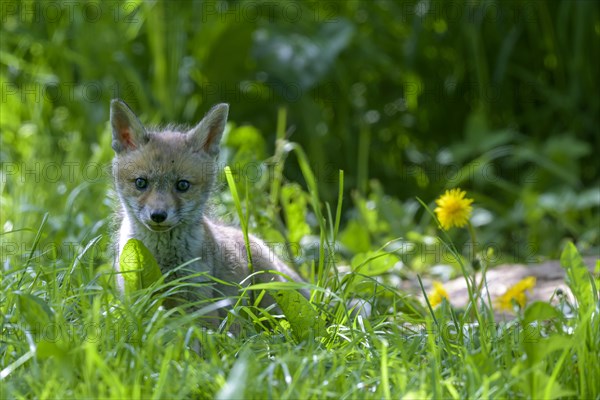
[110,100,302,316]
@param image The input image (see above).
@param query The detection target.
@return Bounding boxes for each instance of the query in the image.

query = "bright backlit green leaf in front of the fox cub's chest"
[119,239,162,293]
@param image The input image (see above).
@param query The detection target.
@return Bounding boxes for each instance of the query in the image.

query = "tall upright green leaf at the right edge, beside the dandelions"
[560,243,594,316]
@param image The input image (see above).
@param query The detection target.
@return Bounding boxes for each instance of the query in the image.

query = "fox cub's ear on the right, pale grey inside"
[187,103,229,157]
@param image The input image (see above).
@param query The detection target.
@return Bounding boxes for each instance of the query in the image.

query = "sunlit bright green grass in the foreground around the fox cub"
[0,122,600,399]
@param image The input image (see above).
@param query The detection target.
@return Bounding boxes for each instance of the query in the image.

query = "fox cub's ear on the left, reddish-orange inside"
[110,99,148,153]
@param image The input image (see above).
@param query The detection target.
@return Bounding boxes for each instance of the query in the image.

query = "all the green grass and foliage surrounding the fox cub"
[0,1,600,398]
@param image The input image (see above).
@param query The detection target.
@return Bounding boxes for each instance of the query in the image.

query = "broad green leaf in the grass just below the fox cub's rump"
[274,290,325,341]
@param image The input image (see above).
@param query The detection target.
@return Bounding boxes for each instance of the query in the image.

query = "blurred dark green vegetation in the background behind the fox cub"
[0,0,600,265]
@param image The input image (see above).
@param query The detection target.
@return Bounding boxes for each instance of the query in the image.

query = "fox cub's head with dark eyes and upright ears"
[110,100,229,232]
